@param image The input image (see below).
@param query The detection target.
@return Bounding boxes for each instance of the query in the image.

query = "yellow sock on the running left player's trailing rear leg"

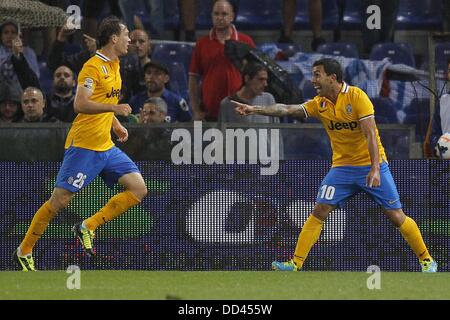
[19,201,56,256]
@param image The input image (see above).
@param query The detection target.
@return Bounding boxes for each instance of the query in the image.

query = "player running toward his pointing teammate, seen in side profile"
[14,17,147,271]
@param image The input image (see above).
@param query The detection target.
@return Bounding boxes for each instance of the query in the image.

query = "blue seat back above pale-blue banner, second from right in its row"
[369,42,416,68]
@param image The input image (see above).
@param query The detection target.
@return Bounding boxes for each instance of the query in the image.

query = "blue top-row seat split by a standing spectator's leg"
[294,0,339,30]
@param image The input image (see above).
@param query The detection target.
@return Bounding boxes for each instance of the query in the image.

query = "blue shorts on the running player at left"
[56,147,140,192]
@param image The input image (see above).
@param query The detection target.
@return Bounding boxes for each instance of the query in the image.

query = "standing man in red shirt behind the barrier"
[189,0,255,121]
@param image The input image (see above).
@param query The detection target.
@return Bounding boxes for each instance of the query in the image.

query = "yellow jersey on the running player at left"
[65,51,122,151]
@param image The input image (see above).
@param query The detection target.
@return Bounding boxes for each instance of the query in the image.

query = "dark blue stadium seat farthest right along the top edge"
[395,0,442,30]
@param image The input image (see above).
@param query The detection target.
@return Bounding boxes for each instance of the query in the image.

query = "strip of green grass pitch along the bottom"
[0,271,450,300]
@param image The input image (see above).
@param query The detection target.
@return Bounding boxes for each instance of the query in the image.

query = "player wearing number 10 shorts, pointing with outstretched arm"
[234,59,437,272]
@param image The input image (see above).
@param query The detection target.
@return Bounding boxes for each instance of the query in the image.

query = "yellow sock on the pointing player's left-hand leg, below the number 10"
[293,214,323,268]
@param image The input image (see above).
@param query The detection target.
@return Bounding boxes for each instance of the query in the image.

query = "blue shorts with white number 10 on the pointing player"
[316,162,402,209]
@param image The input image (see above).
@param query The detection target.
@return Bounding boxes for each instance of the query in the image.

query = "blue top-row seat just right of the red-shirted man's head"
[236,0,282,30]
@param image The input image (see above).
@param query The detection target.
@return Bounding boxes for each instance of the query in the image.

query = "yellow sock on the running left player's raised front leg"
[84,190,140,231]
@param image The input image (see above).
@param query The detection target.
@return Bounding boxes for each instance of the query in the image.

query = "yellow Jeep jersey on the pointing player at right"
[302,83,387,167]
